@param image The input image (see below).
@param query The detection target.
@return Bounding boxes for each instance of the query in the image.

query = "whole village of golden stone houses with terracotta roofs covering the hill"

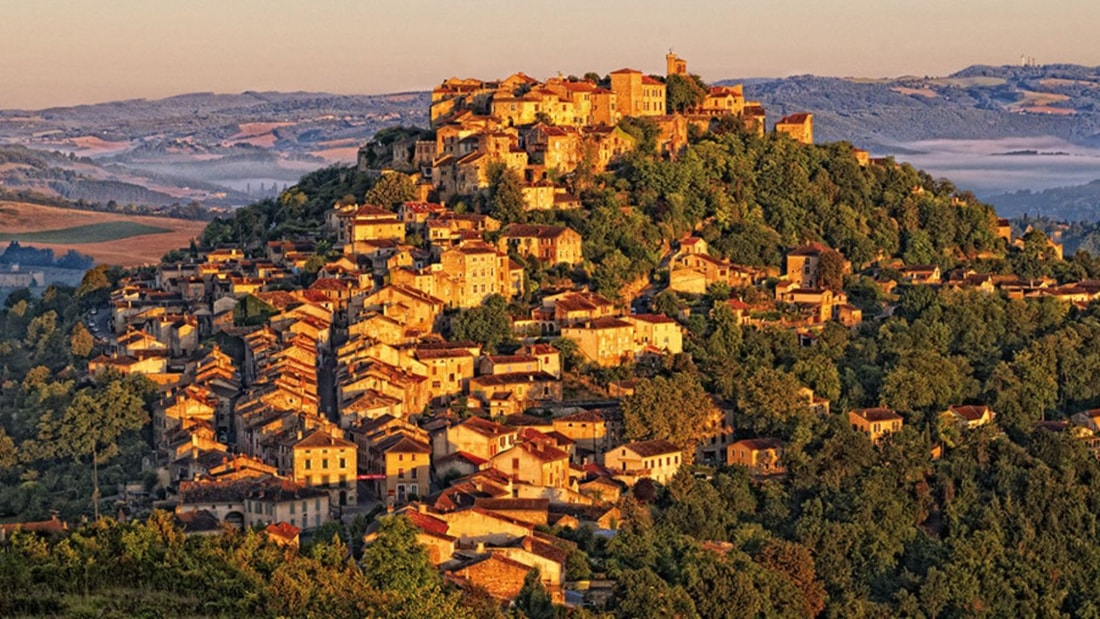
[10,53,1100,605]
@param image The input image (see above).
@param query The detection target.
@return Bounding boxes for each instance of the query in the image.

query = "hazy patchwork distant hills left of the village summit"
[0,92,428,206]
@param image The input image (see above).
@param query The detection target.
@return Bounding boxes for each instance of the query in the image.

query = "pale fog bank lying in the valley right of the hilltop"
[875,136,1100,197]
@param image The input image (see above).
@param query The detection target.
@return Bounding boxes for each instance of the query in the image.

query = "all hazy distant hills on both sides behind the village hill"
[0,65,1100,214]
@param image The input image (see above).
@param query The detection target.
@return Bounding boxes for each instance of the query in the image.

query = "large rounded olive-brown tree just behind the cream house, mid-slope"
[623,373,715,461]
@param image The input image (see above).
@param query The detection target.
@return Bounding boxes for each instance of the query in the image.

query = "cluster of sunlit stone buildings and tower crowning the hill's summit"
[359,52,818,209]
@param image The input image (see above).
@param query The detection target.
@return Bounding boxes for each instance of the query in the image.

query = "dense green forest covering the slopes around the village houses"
[10,114,1100,618]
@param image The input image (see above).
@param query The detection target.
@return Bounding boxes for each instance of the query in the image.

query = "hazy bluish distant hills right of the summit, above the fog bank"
[718,65,1100,150]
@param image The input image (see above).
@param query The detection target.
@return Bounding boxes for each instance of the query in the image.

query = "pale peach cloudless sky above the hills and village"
[0,0,1100,109]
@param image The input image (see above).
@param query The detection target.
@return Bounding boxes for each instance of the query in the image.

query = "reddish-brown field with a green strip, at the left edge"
[0,201,205,266]
